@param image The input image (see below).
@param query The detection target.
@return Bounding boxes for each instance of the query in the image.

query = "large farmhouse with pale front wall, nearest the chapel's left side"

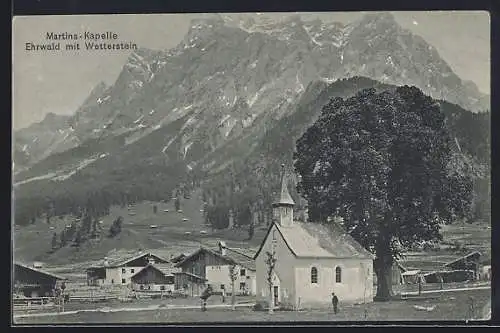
[176,242,256,295]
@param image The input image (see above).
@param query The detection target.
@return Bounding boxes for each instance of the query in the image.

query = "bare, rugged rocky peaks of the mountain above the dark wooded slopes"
[13,13,489,174]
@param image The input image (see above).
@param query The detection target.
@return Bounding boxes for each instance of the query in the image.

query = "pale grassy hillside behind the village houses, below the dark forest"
[14,189,265,272]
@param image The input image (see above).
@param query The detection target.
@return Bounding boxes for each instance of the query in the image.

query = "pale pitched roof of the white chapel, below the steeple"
[254,221,374,259]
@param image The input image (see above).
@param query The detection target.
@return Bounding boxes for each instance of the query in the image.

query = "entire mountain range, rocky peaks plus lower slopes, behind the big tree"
[13,14,490,223]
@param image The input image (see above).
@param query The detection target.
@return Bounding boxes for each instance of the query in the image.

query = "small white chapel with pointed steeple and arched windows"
[255,166,373,308]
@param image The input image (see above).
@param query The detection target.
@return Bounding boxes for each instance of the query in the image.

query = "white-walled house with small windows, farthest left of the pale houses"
[86,251,168,286]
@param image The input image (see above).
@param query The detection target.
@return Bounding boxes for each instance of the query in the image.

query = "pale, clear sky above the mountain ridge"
[12,11,490,130]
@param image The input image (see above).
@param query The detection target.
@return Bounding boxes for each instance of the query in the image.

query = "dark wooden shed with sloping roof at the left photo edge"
[14,263,67,298]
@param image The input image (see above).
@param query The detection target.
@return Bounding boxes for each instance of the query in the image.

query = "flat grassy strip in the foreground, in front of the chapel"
[15,290,491,324]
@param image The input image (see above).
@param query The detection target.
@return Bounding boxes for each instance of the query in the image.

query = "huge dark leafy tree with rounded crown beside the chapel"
[294,86,472,300]
